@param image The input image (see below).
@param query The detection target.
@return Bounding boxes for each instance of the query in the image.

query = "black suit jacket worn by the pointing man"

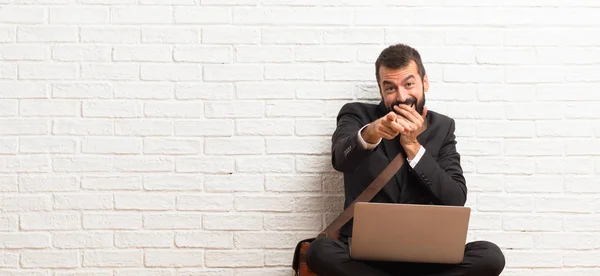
[332,102,467,238]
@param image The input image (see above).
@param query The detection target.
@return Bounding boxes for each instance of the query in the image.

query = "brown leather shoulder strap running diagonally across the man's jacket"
[319,153,404,239]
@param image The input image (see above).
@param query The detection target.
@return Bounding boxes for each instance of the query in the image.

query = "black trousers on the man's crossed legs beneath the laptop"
[306,238,505,276]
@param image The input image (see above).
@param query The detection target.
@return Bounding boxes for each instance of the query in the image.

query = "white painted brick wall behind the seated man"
[0,0,600,276]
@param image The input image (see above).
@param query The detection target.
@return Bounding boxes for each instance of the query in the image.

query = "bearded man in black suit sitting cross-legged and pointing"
[306,44,505,276]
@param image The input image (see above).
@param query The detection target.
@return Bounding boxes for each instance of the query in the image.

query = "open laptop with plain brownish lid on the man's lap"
[349,202,471,264]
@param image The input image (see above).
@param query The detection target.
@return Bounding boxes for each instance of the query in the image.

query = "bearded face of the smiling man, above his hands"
[379,60,429,114]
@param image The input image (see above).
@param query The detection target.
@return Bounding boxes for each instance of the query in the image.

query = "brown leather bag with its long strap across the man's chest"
[292,153,404,276]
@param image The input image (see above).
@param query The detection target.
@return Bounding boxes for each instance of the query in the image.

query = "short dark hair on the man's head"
[375,43,425,84]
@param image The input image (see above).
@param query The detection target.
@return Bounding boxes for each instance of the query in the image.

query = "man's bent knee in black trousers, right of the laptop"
[472,241,506,276]
